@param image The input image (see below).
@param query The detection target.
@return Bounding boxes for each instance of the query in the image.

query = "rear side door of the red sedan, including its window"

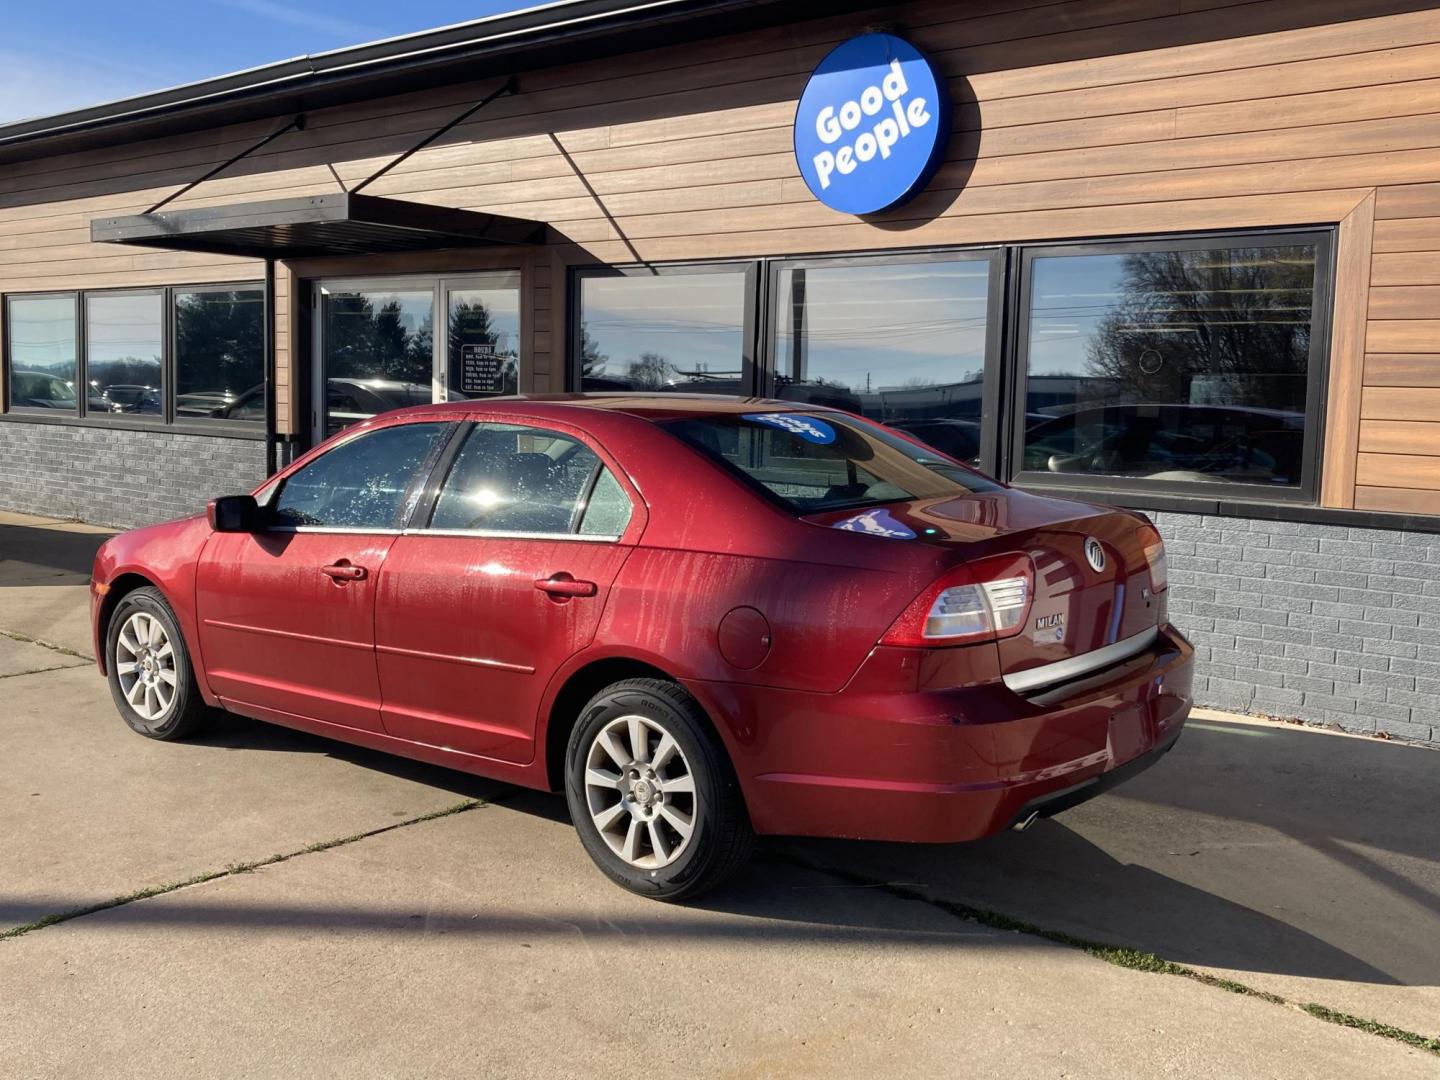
[376,422,639,763]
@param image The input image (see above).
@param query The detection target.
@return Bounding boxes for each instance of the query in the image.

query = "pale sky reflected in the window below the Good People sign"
[776,261,989,392]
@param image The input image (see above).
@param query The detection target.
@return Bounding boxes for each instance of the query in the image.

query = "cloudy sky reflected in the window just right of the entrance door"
[580,272,744,376]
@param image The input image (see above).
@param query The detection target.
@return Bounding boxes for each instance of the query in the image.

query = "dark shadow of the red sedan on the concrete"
[182,717,1440,985]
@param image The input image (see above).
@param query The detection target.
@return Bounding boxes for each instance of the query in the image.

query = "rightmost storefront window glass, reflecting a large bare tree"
[1020,242,1318,488]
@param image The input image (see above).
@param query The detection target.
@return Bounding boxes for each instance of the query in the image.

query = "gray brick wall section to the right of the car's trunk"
[1151,513,1440,743]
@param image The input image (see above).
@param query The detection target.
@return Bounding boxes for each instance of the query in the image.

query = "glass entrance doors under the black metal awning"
[311,271,521,442]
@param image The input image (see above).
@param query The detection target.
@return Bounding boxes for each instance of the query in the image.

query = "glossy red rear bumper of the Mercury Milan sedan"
[694,626,1194,842]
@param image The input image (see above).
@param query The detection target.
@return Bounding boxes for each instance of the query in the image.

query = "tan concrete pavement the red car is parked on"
[0,518,1440,1077]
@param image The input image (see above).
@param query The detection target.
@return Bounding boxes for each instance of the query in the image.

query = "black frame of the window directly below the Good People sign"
[757,252,1005,477]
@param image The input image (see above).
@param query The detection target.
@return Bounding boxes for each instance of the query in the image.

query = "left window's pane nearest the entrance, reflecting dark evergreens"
[174,288,265,423]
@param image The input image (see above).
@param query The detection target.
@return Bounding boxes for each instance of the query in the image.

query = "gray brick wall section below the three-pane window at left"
[0,423,265,528]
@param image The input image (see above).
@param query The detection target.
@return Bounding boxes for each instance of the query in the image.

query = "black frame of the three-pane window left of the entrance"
[0,288,274,442]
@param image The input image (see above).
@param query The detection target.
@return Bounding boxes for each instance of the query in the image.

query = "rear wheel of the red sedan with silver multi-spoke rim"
[564,678,753,900]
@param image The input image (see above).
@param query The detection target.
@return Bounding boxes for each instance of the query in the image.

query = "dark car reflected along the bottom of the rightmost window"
[1024,405,1305,484]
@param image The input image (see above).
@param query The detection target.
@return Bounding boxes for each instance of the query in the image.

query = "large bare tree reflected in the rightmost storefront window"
[1089,248,1315,412]
